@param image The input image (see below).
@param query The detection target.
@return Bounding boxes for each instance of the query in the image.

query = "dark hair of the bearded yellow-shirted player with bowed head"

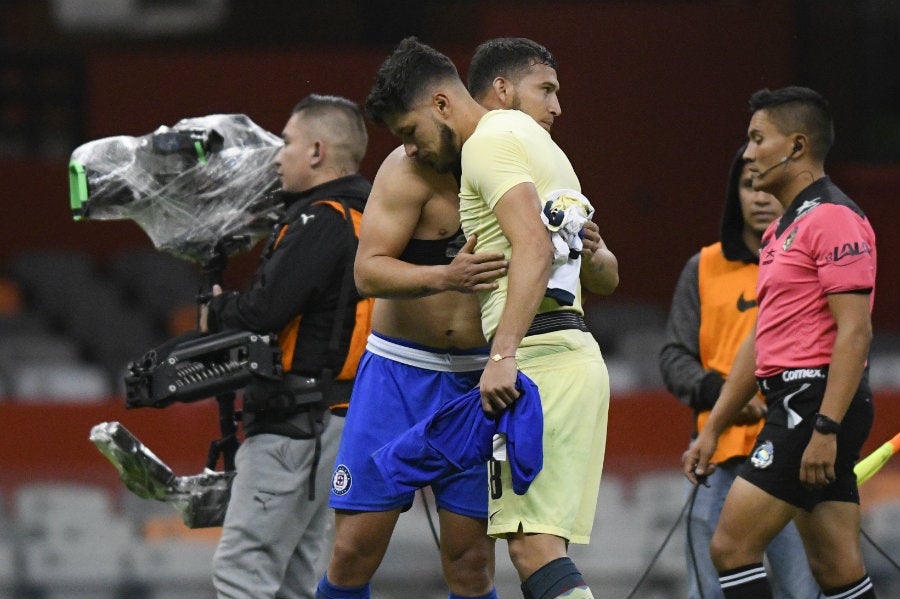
[366,37,459,125]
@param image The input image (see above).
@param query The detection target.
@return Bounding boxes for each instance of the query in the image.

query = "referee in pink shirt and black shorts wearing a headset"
[683,87,876,599]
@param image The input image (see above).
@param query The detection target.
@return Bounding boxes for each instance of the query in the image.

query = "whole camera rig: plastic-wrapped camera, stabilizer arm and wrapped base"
[69,114,283,528]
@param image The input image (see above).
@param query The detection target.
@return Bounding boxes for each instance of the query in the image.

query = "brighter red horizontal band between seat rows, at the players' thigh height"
[0,391,900,489]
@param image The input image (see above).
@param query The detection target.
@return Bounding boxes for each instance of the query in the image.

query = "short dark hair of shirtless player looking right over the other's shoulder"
[467,37,559,99]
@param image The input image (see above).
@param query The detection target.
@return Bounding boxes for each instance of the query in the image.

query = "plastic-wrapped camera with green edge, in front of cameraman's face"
[69,114,282,263]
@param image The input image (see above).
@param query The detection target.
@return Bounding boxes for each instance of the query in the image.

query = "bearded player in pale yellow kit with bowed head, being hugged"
[358,38,609,599]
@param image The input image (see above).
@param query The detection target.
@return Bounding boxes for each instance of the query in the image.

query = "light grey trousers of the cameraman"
[213,414,344,599]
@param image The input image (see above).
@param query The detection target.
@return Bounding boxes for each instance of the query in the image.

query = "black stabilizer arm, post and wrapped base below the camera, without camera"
[96,237,283,528]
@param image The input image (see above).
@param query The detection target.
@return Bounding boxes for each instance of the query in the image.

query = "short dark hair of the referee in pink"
[750,86,834,160]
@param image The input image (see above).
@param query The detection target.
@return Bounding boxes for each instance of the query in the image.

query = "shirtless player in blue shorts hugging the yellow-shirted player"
[318,38,618,599]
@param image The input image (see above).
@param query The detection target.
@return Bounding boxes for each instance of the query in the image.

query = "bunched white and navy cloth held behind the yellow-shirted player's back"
[541,189,594,306]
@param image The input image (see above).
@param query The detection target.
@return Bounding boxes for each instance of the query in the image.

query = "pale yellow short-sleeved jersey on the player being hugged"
[459,110,583,339]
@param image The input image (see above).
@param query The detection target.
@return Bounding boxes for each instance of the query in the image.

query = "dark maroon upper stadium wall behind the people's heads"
[0,0,900,330]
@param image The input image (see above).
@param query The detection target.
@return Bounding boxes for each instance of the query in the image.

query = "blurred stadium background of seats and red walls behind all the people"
[0,0,900,598]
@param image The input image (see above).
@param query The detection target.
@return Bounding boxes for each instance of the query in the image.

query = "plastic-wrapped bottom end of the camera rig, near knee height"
[90,422,235,528]
